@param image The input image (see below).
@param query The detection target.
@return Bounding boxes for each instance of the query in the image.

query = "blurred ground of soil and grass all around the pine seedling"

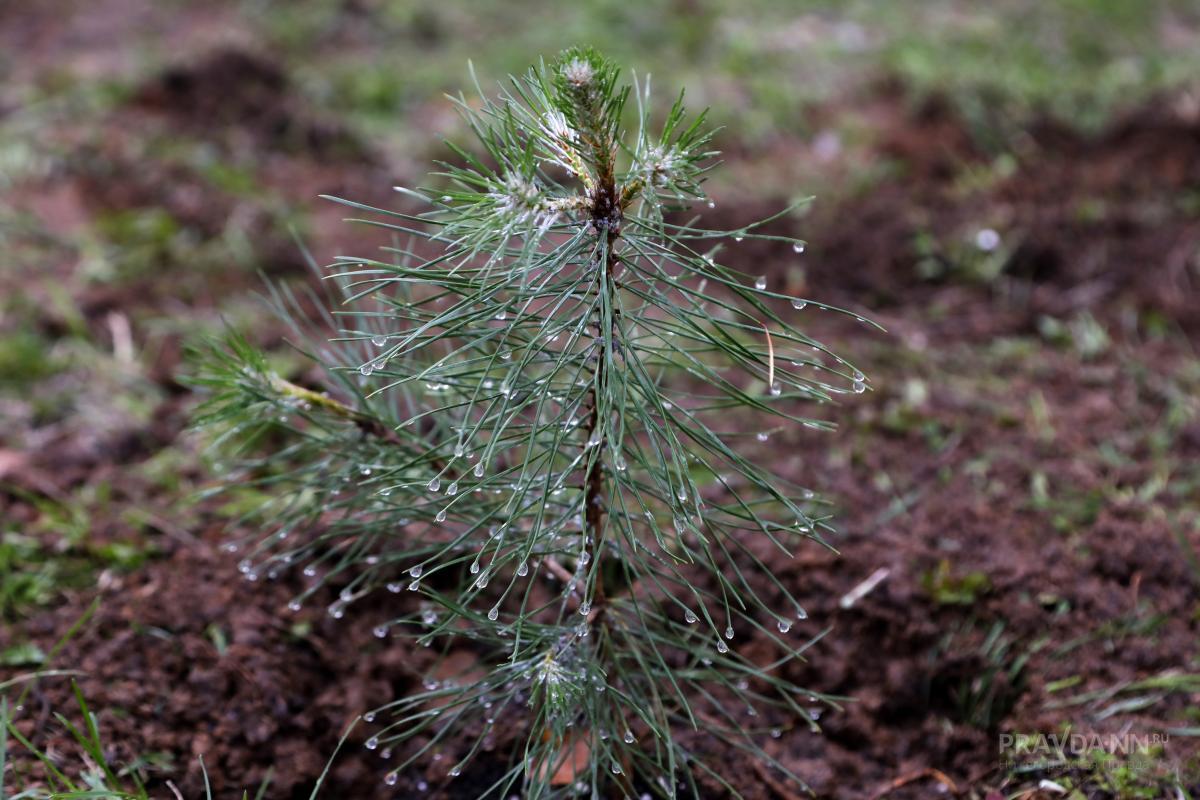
[0,0,1200,798]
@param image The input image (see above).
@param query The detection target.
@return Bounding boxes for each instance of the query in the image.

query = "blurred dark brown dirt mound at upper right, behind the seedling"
[730,89,1200,336]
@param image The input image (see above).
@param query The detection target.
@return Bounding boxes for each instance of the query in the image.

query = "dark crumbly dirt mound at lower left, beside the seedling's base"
[8,537,412,798]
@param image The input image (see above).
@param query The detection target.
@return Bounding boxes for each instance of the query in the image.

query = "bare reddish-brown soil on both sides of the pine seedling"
[0,15,1200,800]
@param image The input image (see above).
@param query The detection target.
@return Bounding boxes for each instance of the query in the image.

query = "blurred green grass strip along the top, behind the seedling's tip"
[242,0,1200,157]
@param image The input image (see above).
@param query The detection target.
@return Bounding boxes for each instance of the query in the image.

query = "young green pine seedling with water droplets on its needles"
[197,49,866,798]
